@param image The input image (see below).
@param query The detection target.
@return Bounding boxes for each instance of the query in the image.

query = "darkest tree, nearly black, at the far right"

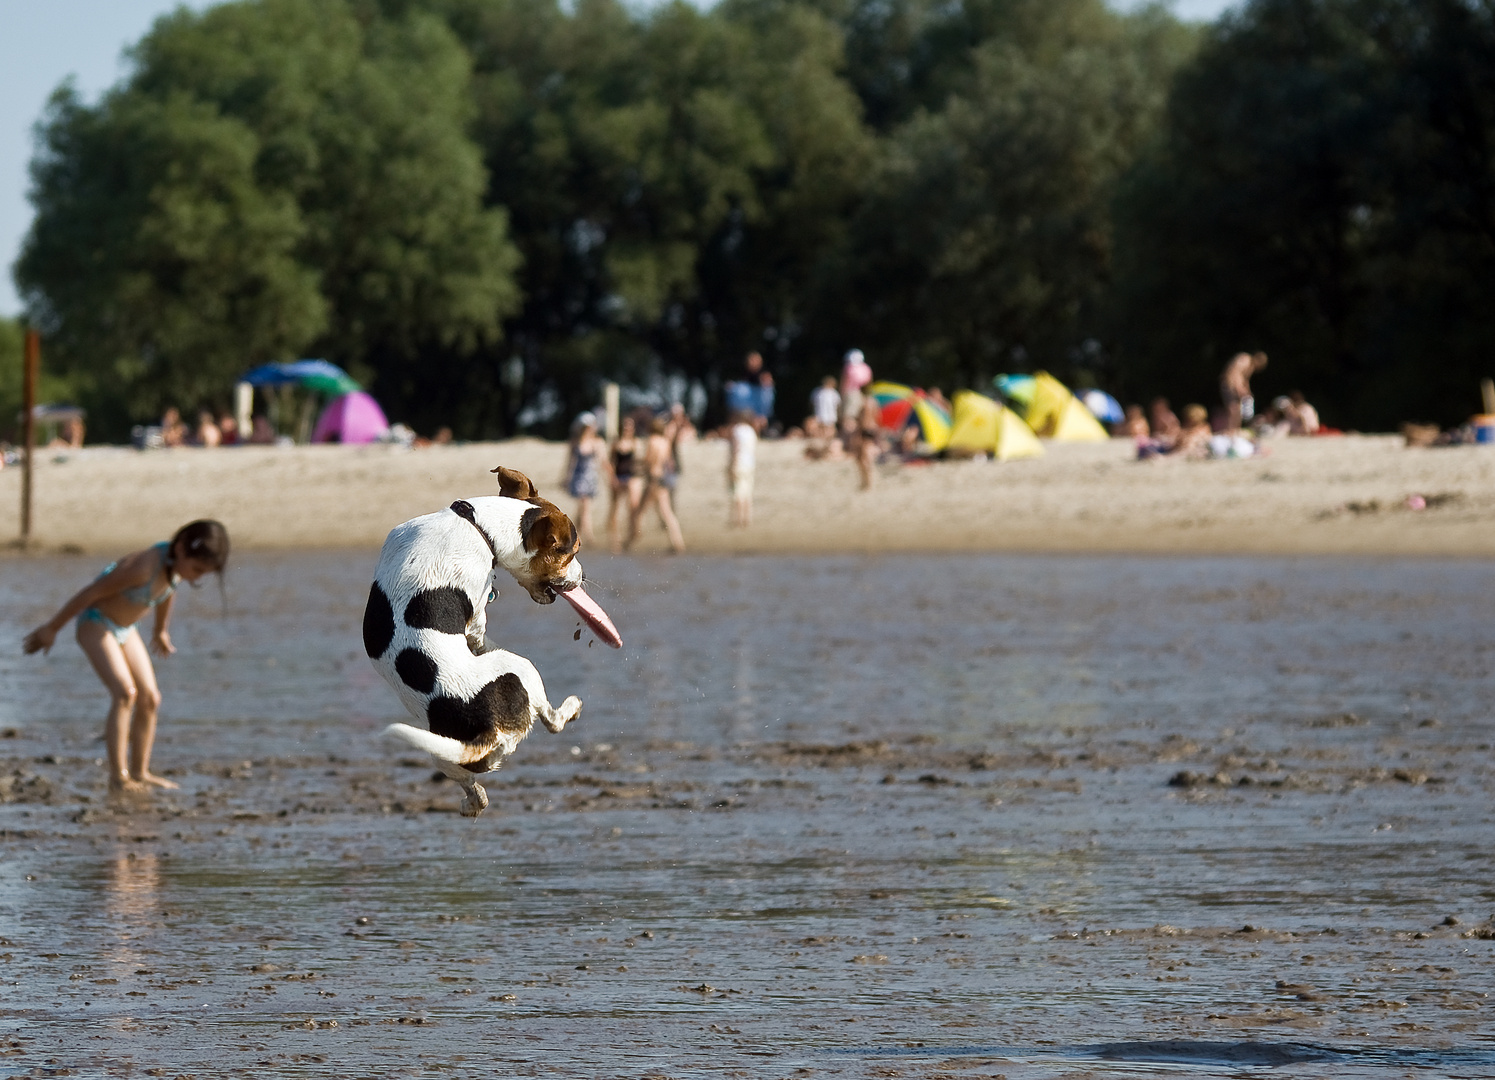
[1112,0,1495,428]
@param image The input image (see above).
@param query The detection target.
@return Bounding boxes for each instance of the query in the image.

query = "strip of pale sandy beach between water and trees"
[0,435,1495,558]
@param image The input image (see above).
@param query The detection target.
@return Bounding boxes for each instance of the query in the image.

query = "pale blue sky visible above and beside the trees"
[0,0,1230,316]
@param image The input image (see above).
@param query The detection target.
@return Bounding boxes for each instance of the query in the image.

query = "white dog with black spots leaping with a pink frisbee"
[363,467,623,817]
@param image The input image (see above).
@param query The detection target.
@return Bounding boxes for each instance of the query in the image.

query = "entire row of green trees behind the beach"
[11,0,1495,437]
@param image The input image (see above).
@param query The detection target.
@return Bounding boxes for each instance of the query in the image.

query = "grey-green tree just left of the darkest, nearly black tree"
[827,0,1192,386]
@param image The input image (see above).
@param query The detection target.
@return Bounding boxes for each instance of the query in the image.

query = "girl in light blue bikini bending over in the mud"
[21,521,229,791]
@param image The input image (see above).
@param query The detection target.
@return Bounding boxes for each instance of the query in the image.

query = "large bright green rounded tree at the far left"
[18,0,519,436]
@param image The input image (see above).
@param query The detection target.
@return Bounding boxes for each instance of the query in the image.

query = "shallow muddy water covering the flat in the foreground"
[0,552,1495,1077]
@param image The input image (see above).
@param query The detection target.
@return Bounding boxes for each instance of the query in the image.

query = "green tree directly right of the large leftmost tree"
[415,0,870,422]
